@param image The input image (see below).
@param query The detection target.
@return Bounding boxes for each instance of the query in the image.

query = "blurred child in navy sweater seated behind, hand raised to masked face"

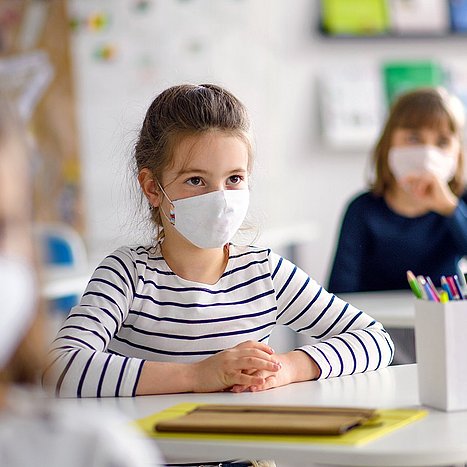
[328,88,467,363]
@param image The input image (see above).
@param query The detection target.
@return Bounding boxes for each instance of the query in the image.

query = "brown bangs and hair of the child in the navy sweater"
[370,88,465,196]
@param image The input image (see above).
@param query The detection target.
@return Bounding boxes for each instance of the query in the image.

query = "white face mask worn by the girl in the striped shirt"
[159,185,250,248]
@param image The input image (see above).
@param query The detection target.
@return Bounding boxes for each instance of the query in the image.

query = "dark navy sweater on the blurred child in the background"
[328,192,467,293]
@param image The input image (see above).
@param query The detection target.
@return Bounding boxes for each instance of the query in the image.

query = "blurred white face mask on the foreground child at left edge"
[0,256,35,368]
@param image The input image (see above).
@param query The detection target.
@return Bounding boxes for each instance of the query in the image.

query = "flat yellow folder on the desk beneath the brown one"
[135,403,428,445]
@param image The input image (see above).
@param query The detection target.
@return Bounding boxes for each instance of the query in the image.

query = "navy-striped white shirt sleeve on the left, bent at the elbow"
[43,249,144,397]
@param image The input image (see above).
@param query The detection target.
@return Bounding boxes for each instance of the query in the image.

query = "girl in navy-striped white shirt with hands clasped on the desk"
[45,84,393,397]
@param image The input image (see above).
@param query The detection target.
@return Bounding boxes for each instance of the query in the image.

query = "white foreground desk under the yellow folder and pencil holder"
[54,365,467,467]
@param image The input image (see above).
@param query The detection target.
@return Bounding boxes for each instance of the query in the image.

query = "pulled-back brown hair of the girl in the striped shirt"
[134,84,253,238]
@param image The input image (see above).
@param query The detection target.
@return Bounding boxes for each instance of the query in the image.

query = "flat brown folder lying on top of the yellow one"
[155,404,379,436]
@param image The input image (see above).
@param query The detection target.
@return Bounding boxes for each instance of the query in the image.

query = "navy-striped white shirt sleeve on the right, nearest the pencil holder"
[269,253,394,379]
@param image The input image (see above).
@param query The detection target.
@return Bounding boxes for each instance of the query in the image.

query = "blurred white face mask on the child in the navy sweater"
[388,146,457,183]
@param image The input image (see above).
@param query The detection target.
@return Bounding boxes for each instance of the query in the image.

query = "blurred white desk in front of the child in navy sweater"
[338,290,416,328]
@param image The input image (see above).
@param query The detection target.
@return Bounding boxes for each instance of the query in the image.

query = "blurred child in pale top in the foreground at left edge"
[0,97,162,467]
